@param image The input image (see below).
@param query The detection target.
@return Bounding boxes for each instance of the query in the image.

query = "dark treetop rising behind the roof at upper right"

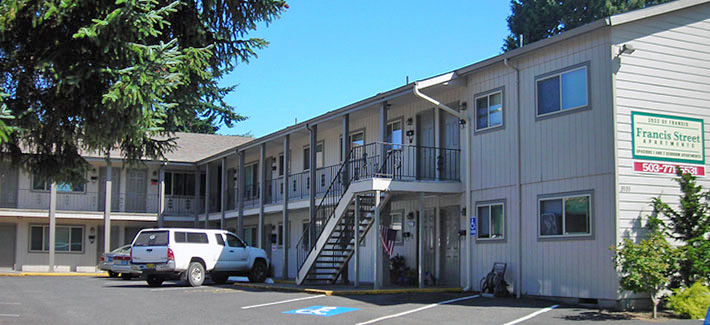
[503,0,672,52]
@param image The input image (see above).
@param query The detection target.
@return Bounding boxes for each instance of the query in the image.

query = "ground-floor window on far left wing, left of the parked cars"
[30,225,84,253]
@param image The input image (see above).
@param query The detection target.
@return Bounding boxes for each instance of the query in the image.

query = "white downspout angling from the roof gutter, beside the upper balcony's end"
[413,81,473,291]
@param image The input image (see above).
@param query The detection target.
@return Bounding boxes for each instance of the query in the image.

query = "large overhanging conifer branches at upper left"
[0,0,287,183]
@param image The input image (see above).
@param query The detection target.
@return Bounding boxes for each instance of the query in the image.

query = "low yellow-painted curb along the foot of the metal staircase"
[234,282,463,296]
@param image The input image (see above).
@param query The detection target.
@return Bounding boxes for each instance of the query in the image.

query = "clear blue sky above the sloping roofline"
[218,0,510,137]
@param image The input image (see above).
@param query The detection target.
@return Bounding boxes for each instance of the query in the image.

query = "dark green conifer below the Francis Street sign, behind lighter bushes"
[652,170,710,288]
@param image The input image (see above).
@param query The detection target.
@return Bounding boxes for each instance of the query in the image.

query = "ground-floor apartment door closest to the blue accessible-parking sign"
[439,206,460,286]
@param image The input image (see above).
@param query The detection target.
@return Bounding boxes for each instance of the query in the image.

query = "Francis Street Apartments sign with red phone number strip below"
[631,112,705,176]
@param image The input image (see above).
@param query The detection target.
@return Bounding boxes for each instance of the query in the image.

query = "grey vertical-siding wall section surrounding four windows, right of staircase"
[466,30,616,299]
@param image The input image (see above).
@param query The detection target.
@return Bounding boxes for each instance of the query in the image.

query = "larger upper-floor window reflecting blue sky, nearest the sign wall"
[537,65,589,116]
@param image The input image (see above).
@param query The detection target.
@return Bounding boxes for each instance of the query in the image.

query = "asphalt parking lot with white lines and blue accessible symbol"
[0,277,702,324]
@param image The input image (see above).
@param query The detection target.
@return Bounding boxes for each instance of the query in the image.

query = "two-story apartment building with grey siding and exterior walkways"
[0,0,710,304]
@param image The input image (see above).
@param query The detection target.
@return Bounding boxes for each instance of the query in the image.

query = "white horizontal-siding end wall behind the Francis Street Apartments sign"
[611,4,710,247]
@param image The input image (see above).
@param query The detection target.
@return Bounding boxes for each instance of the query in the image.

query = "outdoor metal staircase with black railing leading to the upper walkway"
[296,145,390,285]
